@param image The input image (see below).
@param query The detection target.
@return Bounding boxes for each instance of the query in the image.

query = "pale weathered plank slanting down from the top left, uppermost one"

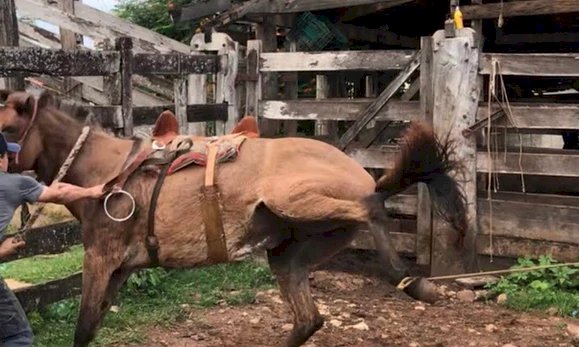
[15,0,190,54]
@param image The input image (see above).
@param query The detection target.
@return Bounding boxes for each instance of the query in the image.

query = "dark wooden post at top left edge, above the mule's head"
[0,0,25,90]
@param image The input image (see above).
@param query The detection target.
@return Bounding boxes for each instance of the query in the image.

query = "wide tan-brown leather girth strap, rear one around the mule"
[200,143,229,263]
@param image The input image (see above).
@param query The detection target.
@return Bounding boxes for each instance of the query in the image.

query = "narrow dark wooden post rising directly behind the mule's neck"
[115,37,133,136]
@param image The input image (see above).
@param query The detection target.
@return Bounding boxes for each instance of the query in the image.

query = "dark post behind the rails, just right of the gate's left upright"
[256,16,279,137]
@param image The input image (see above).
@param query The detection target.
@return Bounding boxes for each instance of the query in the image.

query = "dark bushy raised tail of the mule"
[368,122,467,242]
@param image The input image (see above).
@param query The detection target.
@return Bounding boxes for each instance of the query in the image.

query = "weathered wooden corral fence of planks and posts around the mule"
[0,0,579,311]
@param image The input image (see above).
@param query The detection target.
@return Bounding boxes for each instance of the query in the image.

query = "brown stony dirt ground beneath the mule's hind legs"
[120,255,579,347]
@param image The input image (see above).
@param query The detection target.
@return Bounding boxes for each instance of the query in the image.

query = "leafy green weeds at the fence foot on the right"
[487,256,579,317]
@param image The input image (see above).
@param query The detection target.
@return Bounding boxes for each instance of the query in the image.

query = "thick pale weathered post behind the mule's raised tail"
[431,28,480,276]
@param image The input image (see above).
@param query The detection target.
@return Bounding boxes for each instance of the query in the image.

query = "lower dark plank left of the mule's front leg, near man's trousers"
[14,273,82,312]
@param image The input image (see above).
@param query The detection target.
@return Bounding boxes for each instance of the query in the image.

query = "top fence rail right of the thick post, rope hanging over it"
[480,53,579,77]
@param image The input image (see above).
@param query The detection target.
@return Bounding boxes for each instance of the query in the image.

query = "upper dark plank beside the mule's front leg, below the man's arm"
[2,221,81,263]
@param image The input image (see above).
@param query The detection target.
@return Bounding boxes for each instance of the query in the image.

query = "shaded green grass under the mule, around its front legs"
[19,261,274,347]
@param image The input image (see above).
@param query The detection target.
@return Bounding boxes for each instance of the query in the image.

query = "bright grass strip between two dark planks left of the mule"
[0,245,84,284]
